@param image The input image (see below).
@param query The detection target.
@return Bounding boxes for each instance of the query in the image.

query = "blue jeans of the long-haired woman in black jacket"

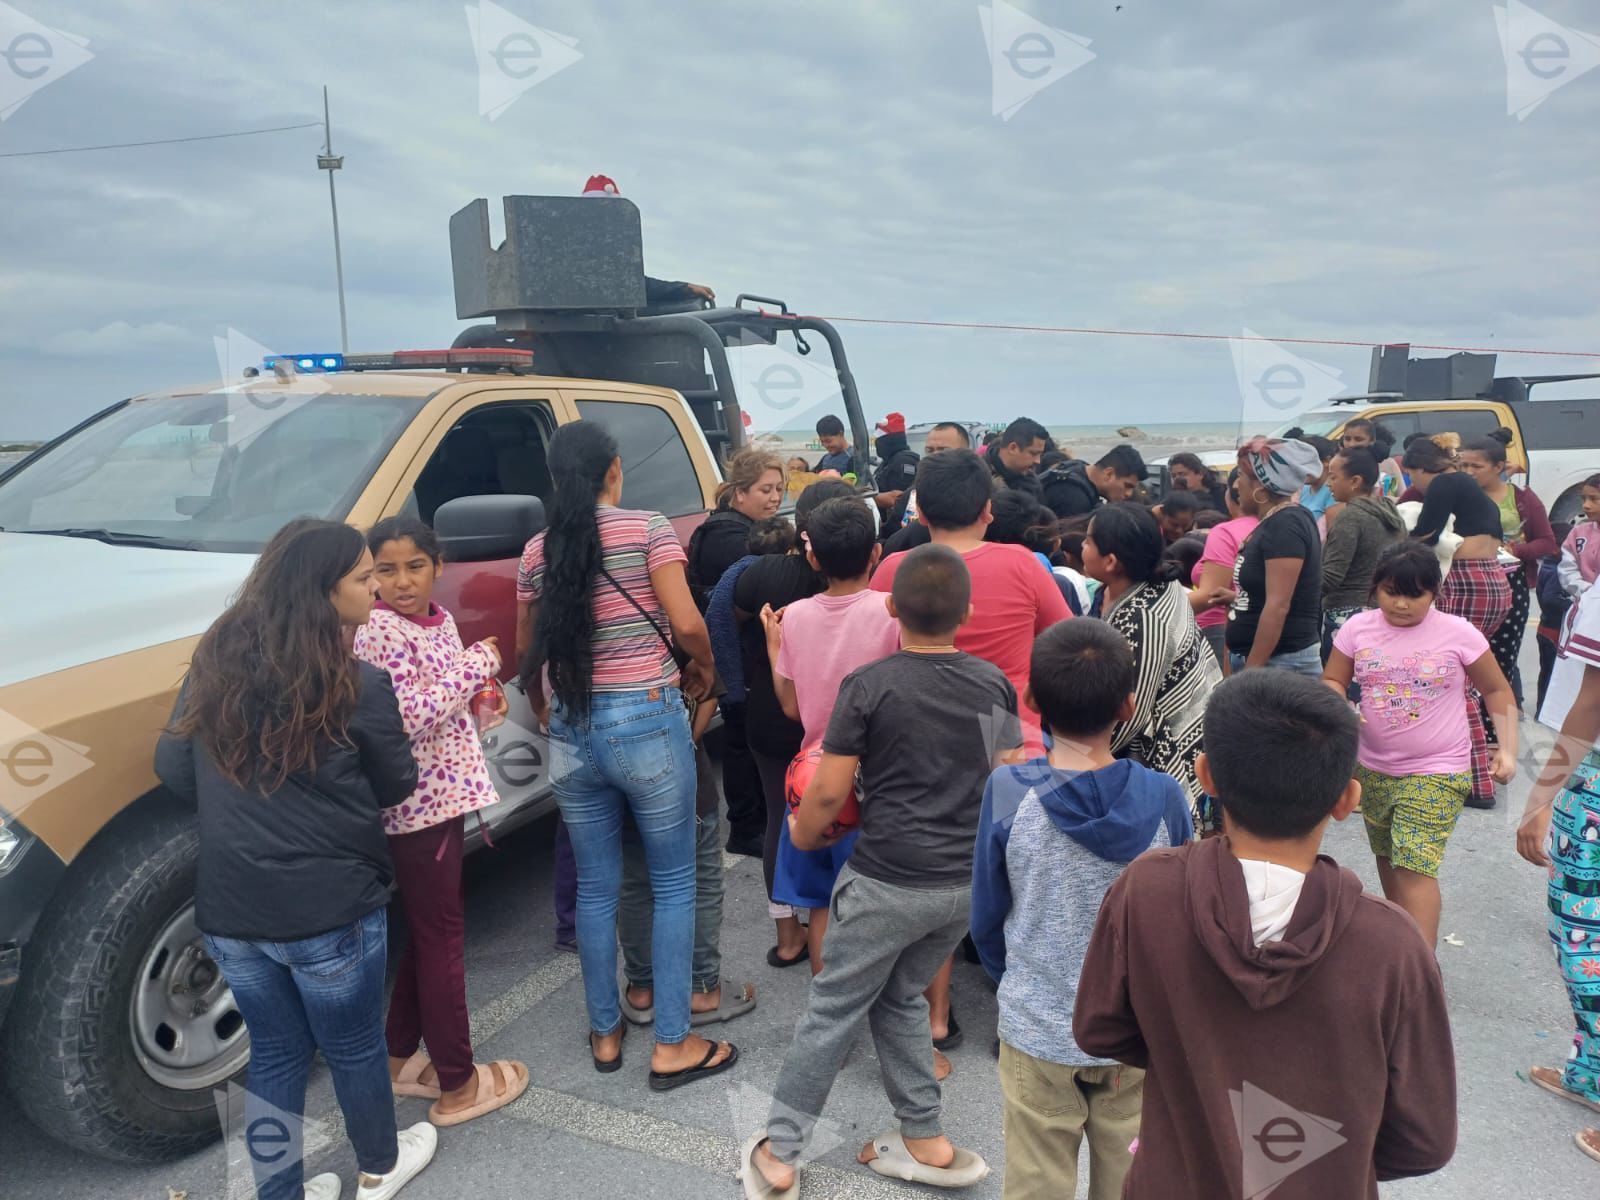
[205,909,398,1200]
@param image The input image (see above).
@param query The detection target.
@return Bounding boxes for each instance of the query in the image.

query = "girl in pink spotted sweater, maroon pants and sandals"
[355,517,528,1125]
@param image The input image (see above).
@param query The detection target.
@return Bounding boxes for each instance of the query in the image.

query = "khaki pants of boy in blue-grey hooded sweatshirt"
[1000,1042,1144,1200]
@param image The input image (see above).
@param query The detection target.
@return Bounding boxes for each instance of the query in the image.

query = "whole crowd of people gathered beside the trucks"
[157,414,1600,1200]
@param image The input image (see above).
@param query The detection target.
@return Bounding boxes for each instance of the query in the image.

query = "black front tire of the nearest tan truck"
[5,806,250,1162]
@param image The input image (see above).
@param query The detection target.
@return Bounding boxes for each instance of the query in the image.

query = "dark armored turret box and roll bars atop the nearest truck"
[450,195,870,459]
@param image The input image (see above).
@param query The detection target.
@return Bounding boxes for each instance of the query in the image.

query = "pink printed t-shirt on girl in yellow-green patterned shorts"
[1333,608,1490,776]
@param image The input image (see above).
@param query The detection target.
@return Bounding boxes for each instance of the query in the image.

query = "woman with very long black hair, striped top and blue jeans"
[517,421,739,1091]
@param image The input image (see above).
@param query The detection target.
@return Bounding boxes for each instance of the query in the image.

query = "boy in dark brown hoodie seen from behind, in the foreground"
[1072,670,1456,1200]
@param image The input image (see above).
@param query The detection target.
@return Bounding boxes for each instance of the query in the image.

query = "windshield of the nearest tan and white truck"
[0,390,426,554]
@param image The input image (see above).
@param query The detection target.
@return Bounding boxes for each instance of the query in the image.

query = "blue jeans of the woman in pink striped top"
[550,688,694,1043]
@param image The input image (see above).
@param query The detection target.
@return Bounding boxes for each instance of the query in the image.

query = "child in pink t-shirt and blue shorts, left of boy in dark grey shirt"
[762,496,899,974]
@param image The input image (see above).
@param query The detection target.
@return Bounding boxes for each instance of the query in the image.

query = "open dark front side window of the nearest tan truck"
[405,402,555,523]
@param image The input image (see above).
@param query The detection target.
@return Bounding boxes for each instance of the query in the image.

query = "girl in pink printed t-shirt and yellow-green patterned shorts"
[1323,541,1517,946]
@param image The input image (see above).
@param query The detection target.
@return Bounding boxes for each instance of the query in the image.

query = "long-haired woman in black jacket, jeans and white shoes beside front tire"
[155,520,438,1200]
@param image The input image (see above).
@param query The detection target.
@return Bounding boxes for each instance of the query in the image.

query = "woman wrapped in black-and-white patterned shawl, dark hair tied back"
[1083,501,1222,829]
